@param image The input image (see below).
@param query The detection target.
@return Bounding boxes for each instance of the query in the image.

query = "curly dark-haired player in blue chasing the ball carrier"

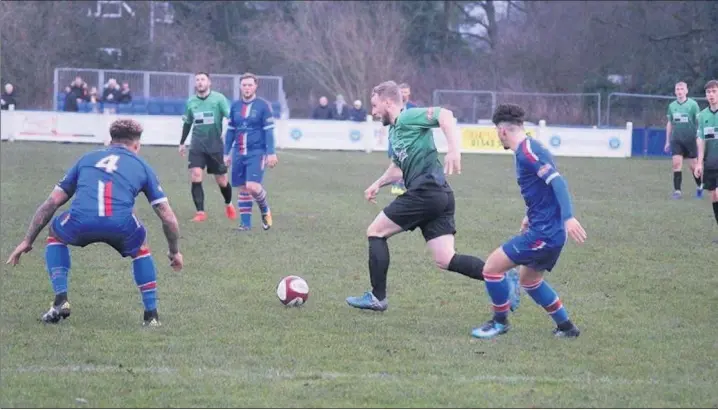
[471,104,586,339]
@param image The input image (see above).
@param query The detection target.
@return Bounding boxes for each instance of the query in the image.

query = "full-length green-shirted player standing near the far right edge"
[664,81,703,199]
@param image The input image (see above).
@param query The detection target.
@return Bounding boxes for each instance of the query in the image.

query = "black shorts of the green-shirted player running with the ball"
[384,175,456,242]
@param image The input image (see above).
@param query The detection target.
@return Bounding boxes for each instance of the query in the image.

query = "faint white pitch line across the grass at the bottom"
[8,365,714,387]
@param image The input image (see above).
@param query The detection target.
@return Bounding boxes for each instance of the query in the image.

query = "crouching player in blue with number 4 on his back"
[7,119,183,327]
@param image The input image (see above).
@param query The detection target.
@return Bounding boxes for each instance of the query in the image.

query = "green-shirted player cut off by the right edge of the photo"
[695,80,718,243]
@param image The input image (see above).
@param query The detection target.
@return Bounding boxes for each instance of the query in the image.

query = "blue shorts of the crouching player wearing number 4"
[52,211,147,258]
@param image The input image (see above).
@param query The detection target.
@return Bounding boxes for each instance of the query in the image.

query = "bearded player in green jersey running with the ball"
[346,81,519,311]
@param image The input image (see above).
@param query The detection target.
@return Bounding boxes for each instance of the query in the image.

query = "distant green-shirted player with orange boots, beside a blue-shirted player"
[179,72,237,222]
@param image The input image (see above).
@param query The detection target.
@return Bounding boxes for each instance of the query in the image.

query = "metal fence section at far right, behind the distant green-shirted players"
[606,93,708,128]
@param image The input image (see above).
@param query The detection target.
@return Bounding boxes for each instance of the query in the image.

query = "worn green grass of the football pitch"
[0,142,718,408]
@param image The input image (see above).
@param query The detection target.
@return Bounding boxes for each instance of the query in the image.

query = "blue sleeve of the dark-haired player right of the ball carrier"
[519,140,573,222]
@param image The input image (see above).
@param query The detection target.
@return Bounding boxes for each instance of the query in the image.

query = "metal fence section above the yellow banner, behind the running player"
[433,90,601,126]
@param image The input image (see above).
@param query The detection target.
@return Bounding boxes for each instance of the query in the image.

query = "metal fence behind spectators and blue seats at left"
[53,68,288,112]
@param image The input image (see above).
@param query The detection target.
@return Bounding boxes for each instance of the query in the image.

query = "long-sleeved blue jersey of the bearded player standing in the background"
[224,97,275,156]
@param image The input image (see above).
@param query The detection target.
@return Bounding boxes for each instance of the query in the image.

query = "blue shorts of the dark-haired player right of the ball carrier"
[501,231,565,272]
